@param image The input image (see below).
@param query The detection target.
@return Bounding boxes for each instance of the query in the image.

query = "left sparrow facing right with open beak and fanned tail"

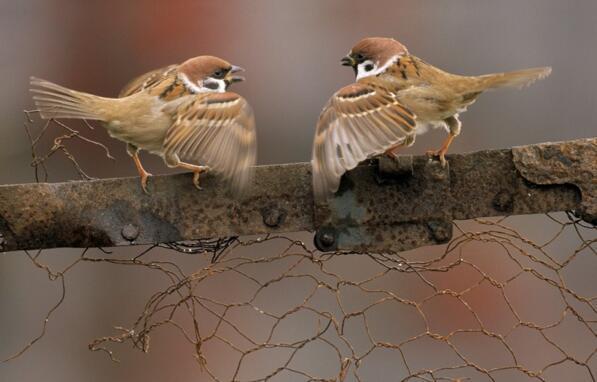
[31,56,256,192]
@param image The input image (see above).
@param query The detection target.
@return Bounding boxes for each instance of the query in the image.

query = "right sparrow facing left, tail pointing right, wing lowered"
[311,37,551,200]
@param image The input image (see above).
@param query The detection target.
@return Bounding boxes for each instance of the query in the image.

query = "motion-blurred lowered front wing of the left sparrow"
[164,92,257,193]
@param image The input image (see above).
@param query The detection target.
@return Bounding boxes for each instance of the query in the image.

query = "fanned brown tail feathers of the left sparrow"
[30,77,104,120]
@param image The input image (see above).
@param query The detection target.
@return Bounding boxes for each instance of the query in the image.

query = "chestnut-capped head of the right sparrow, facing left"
[341,37,408,80]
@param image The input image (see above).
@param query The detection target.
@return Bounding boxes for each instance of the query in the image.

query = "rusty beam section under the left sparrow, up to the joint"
[0,163,313,251]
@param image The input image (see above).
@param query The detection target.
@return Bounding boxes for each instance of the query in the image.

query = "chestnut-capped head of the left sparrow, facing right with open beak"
[178,56,245,93]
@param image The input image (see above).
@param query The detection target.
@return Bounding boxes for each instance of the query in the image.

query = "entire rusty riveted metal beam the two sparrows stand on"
[0,138,597,251]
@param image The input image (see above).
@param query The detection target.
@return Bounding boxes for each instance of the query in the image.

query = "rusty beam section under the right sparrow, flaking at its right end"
[315,139,597,251]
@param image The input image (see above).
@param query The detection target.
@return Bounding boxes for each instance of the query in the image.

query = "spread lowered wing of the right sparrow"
[311,81,416,200]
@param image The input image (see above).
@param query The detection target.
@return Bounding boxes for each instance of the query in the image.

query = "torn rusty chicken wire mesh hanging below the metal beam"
[5,112,597,381]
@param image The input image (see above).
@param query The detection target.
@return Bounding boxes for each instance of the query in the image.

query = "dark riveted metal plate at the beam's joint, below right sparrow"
[315,156,452,251]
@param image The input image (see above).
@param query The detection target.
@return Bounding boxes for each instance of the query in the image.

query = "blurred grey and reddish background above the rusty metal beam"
[0,0,597,183]
